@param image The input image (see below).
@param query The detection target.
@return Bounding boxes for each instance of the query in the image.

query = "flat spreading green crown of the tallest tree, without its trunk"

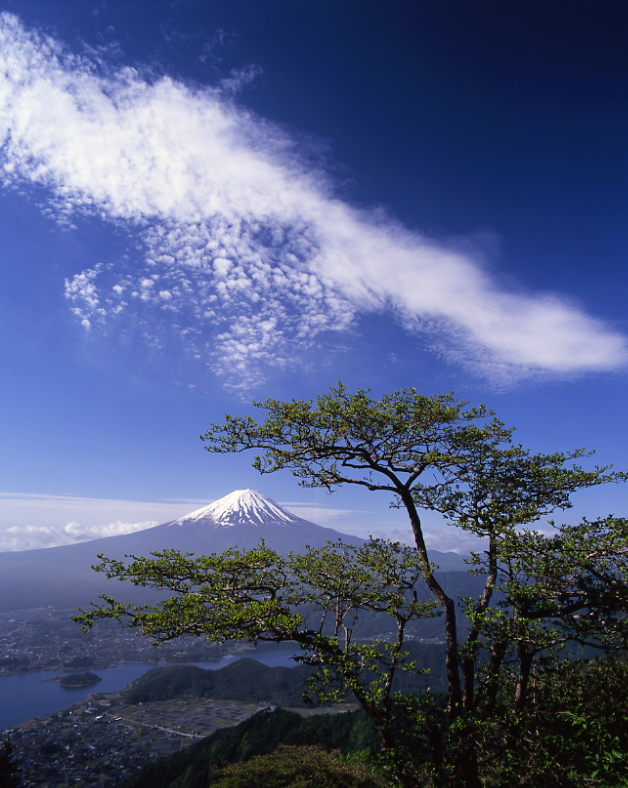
[201,384,480,492]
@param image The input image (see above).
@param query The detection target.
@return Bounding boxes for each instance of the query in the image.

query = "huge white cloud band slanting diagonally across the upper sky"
[0,14,628,386]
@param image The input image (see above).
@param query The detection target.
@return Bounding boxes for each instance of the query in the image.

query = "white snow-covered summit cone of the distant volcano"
[171,490,303,528]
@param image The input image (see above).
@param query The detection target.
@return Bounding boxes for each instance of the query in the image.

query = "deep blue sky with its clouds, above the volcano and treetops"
[0,0,628,549]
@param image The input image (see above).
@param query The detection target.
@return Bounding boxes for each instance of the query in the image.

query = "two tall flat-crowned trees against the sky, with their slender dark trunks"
[201,384,626,720]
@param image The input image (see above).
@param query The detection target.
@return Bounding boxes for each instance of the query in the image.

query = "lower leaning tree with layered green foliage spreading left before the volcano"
[75,539,435,748]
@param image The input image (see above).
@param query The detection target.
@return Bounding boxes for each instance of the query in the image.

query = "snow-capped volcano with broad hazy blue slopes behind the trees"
[0,490,465,611]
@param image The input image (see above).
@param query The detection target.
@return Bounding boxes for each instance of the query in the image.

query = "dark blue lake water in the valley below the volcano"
[0,643,299,730]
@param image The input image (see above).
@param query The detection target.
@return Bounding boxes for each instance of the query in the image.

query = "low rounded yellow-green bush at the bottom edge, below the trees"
[212,744,388,788]
